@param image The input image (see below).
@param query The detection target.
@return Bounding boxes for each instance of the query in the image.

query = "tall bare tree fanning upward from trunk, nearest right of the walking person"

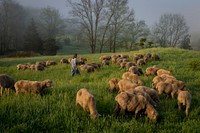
[68,0,105,53]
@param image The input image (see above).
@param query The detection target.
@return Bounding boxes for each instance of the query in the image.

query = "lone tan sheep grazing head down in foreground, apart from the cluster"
[76,88,100,119]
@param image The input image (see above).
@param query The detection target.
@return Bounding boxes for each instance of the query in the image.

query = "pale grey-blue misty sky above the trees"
[15,0,200,33]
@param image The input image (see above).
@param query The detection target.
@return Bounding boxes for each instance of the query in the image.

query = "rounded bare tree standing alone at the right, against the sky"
[153,14,189,47]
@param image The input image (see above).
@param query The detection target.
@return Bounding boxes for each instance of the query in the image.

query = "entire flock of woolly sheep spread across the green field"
[0,53,191,121]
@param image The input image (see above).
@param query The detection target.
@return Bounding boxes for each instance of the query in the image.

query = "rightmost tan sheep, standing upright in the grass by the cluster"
[177,90,192,116]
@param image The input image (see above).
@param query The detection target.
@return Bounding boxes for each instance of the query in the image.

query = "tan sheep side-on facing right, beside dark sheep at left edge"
[14,79,54,95]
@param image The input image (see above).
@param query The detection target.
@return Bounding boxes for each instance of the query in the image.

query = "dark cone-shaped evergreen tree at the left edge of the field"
[24,18,43,54]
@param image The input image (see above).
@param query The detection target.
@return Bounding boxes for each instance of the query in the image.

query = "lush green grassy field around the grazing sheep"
[0,48,200,133]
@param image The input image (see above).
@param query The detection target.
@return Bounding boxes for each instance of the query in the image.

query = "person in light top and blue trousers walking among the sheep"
[70,54,80,77]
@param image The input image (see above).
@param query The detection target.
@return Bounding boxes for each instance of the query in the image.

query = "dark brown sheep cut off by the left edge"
[0,74,15,96]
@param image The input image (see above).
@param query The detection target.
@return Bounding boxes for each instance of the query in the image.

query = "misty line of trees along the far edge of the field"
[0,0,191,55]
